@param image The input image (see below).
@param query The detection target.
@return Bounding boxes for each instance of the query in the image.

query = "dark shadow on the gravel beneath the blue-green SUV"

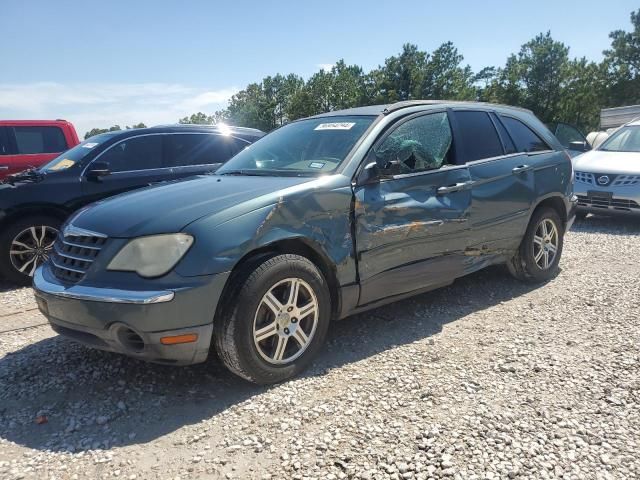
[0,267,537,452]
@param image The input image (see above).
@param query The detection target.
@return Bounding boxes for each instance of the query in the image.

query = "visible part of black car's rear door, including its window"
[165,133,248,178]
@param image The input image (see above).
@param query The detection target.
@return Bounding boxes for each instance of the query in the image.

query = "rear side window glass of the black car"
[167,134,236,166]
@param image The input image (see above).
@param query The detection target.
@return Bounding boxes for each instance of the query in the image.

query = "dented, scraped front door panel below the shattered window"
[354,167,471,305]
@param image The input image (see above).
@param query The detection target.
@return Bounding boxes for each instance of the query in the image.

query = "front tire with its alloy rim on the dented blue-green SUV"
[214,254,331,384]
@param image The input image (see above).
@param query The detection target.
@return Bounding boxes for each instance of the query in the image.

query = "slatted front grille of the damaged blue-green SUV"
[51,232,107,283]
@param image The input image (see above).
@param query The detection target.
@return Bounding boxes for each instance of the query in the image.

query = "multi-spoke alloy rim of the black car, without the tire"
[9,225,58,277]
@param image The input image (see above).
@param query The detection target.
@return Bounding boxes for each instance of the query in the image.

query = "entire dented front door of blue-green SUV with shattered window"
[354,112,471,305]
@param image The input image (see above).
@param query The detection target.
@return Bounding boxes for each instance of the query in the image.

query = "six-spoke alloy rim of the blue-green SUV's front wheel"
[253,278,319,365]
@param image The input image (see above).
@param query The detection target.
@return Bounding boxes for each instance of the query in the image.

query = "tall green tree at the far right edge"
[604,10,640,107]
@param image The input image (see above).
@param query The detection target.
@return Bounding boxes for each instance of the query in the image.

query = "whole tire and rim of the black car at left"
[0,215,61,286]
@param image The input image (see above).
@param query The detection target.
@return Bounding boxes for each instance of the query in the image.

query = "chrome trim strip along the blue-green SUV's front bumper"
[33,267,175,305]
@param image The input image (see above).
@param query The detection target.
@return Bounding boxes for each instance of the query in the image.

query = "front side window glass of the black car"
[96,135,163,172]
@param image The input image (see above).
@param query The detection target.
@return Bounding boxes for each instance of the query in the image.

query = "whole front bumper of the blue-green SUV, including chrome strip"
[33,265,228,365]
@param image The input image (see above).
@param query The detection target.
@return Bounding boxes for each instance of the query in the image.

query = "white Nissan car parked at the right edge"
[573,119,640,217]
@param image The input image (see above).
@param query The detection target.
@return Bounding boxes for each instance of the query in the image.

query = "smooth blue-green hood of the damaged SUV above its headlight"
[69,175,314,238]
